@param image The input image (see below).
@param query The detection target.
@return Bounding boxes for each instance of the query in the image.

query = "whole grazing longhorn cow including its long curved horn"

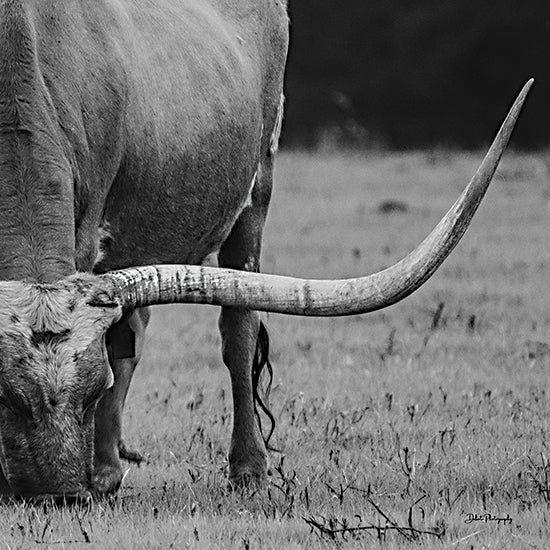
[0,0,529,500]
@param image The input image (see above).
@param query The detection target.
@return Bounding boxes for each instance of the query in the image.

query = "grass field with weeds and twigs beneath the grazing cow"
[0,151,550,550]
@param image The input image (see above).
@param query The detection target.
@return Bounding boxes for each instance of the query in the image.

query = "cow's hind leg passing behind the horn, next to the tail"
[219,164,273,485]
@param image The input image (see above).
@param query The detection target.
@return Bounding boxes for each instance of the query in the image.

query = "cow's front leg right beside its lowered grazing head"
[92,308,149,493]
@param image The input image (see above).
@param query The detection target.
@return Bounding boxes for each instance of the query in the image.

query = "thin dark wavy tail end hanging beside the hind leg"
[252,321,277,451]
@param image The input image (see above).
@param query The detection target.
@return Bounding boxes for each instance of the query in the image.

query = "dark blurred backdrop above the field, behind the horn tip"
[282,0,550,149]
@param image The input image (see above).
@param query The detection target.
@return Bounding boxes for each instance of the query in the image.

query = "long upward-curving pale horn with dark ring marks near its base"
[104,79,533,316]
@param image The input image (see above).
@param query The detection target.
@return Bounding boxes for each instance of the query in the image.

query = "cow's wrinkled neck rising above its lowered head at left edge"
[0,0,75,282]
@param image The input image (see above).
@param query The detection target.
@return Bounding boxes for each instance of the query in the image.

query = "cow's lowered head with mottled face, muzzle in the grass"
[0,274,122,499]
